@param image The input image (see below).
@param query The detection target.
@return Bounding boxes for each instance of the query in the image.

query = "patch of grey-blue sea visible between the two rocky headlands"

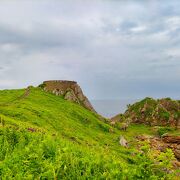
[91,99,138,118]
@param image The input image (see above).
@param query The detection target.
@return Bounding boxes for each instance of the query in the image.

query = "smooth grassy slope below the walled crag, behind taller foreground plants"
[0,88,118,148]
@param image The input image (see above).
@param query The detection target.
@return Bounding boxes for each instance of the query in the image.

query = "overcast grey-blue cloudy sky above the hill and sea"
[0,0,180,99]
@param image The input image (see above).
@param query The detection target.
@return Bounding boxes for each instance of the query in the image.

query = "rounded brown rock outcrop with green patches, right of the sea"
[124,98,180,129]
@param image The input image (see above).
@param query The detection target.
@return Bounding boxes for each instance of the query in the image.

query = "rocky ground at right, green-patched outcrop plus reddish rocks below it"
[110,98,180,168]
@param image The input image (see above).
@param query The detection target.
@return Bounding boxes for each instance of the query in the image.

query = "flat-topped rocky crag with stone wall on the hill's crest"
[41,80,95,112]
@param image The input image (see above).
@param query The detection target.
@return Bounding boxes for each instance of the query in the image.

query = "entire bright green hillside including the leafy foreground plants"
[0,87,178,179]
